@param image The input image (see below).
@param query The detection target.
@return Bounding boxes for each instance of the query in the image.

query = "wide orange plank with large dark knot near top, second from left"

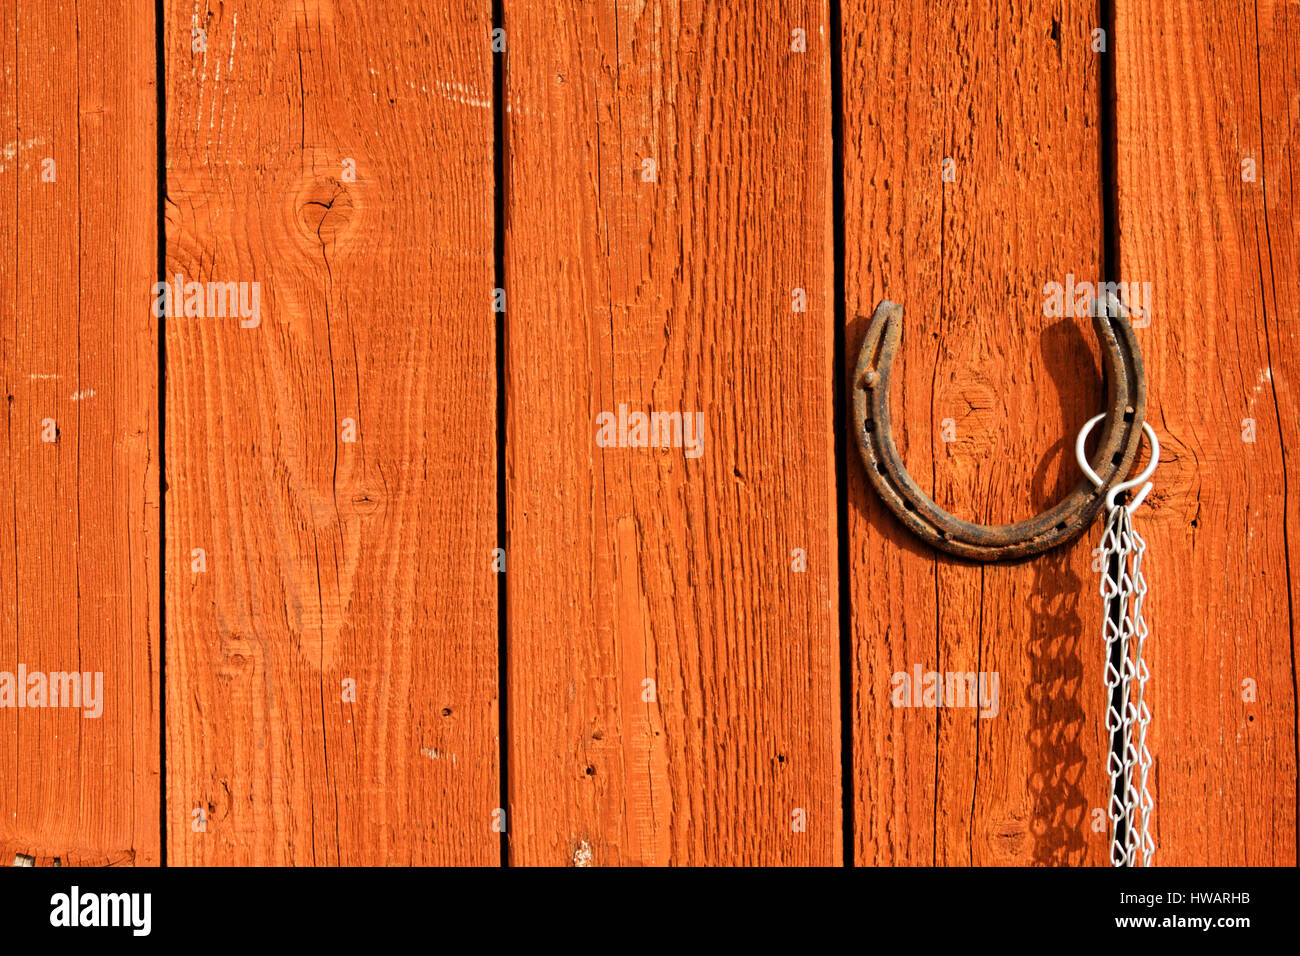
[165,0,499,864]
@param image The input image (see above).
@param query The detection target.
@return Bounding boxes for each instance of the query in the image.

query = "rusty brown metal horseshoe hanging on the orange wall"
[850,299,1147,561]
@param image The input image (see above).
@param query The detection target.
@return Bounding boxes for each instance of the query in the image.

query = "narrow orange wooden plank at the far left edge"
[0,0,161,865]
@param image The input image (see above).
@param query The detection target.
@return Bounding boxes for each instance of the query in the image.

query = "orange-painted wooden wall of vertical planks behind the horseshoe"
[0,0,1300,865]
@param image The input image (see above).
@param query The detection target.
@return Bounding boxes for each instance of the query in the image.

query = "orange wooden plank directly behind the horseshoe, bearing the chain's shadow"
[842,0,1105,865]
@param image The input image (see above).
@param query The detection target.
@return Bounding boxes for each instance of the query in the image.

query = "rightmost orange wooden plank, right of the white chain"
[1115,0,1300,866]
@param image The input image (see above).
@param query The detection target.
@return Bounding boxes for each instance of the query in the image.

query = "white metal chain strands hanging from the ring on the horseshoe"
[1101,503,1156,866]
